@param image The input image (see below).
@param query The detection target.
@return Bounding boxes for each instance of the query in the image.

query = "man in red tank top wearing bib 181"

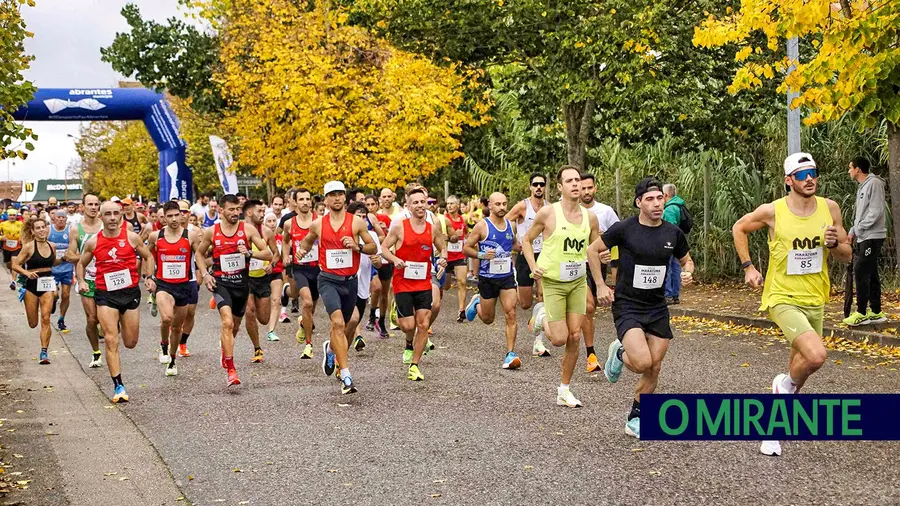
[196,195,272,386]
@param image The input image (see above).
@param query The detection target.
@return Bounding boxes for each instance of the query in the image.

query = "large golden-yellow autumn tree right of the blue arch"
[215,0,487,192]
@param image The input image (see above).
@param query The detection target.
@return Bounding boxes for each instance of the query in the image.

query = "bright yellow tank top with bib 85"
[759,197,834,311]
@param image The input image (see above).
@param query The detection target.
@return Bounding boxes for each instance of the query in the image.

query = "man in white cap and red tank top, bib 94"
[295,181,378,394]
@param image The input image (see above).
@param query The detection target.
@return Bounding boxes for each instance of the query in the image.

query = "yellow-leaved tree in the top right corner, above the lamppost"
[694,0,900,263]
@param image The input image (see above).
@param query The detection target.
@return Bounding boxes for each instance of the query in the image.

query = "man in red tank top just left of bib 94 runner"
[281,188,320,359]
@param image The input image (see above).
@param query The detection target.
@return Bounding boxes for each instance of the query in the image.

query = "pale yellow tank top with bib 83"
[537,202,591,282]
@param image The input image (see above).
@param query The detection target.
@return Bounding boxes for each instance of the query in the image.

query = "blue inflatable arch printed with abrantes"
[13,88,193,202]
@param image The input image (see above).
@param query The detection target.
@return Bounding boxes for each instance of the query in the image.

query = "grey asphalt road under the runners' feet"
[15,289,900,505]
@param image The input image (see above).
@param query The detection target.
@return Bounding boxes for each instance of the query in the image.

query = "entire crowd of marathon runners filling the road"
[0,153,864,455]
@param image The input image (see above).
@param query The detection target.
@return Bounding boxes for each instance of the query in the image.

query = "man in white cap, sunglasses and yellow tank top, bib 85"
[732,153,851,455]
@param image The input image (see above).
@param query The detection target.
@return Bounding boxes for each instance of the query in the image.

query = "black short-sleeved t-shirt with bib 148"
[602,216,690,309]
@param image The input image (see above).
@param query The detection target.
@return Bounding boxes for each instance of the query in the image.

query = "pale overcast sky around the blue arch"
[0,0,191,181]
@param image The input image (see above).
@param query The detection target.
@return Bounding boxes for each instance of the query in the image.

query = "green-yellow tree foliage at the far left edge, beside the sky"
[0,0,37,160]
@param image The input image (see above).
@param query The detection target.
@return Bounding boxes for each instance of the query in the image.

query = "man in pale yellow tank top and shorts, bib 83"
[517,165,600,408]
